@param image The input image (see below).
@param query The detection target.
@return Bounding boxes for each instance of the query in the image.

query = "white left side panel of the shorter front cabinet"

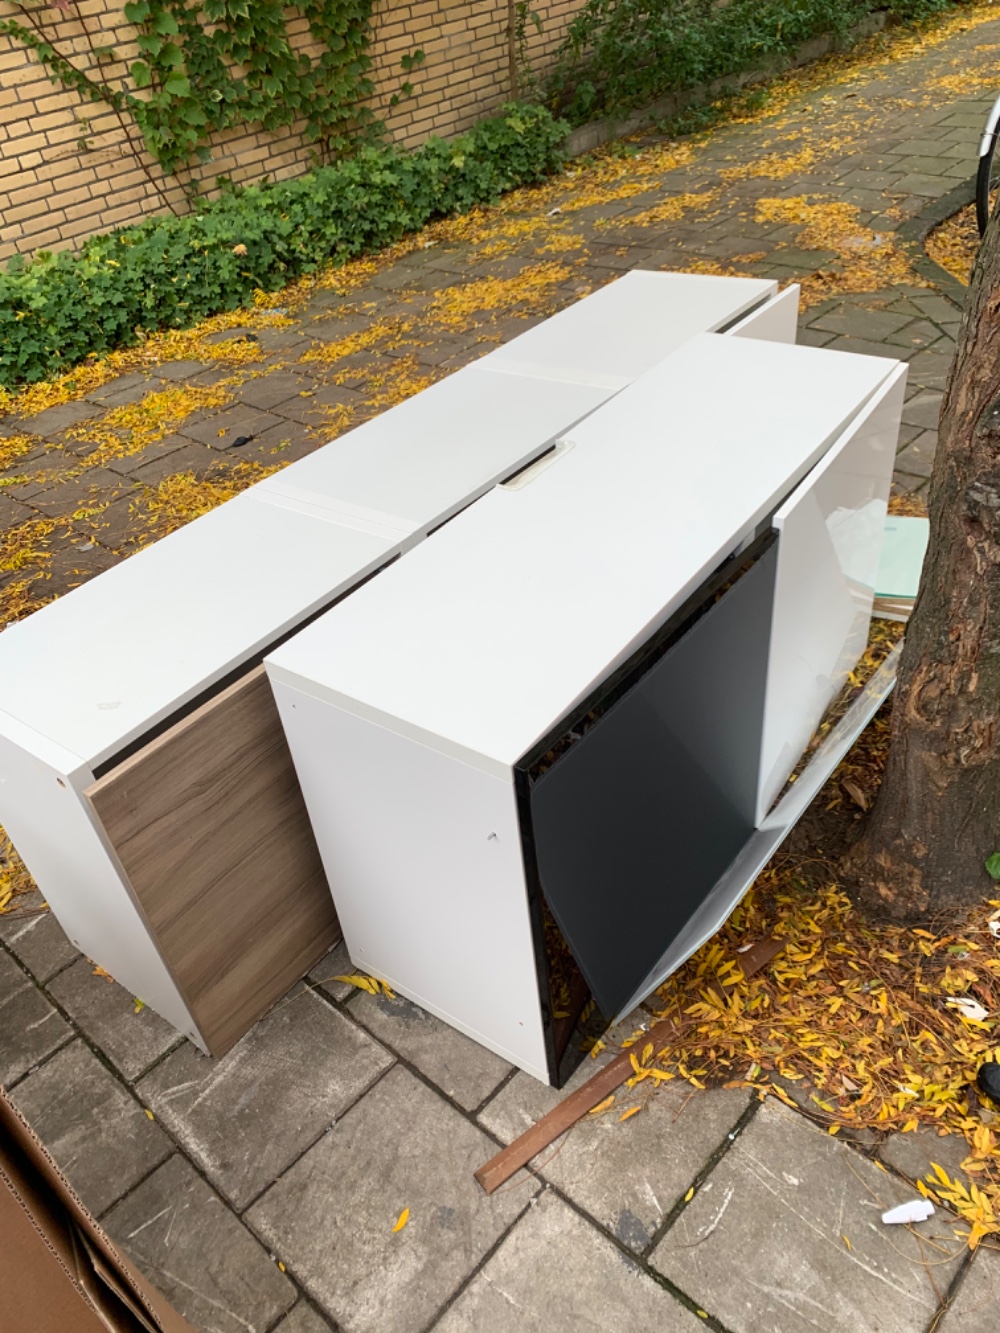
[273,677,548,1081]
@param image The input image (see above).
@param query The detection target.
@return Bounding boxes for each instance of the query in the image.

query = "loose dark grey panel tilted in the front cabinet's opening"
[529,547,776,1016]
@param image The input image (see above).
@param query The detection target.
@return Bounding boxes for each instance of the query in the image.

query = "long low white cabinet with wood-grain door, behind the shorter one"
[0,273,775,1053]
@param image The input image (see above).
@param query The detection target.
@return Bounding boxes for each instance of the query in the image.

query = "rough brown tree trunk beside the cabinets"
[845,220,1000,921]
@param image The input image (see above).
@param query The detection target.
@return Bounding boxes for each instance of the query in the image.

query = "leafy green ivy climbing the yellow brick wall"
[0,0,384,172]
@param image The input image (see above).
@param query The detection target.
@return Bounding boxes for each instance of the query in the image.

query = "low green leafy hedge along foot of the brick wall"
[0,104,567,389]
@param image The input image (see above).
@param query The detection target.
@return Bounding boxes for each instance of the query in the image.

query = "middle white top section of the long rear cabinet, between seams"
[259,367,615,540]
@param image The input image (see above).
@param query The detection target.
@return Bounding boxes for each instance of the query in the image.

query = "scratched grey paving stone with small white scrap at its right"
[651,1101,961,1333]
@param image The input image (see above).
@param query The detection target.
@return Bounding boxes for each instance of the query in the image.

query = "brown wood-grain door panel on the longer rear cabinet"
[85,667,340,1056]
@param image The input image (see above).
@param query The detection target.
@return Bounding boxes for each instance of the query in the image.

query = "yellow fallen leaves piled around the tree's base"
[633,741,1000,1246]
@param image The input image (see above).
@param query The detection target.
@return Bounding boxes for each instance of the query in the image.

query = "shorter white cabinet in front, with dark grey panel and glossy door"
[265,335,905,1082]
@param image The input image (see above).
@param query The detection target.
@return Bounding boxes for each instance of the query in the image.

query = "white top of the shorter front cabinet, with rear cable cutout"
[268,333,897,772]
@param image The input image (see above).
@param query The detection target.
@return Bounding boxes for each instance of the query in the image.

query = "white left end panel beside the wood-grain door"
[0,736,199,1041]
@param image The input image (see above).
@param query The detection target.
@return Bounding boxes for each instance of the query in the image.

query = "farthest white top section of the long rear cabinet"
[476,271,777,389]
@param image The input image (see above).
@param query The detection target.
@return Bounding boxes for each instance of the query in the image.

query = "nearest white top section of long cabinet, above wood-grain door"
[0,492,395,765]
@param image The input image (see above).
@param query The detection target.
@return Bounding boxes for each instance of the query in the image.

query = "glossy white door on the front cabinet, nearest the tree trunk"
[757,368,905,820]
